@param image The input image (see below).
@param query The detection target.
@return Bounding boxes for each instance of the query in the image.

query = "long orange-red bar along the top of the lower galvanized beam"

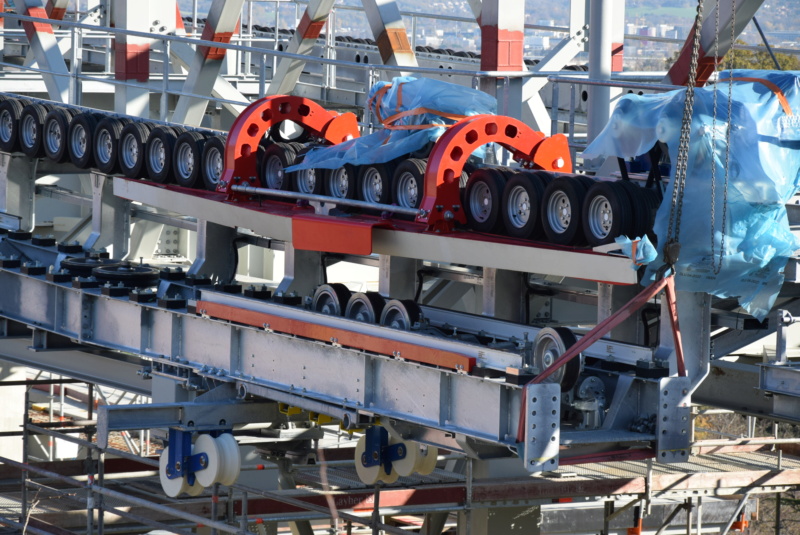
[197,301,476,373]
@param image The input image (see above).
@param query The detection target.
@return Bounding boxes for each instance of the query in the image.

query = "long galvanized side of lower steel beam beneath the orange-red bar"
[0,270,519,445]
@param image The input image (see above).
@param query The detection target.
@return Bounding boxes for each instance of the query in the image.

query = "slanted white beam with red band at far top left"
[14,0,69,102]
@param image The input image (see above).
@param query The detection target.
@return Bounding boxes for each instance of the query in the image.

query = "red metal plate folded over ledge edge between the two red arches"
[292,214,391,255]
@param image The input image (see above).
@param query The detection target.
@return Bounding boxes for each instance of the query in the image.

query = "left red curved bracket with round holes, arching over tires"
[217,95,359,195]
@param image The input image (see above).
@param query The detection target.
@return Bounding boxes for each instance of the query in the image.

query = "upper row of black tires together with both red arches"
[0,92,661,249]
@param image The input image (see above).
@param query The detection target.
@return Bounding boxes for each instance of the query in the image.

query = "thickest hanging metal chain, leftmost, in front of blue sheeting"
[663,0,703,267]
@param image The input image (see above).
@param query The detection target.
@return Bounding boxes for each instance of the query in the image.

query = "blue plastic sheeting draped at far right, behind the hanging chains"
[584,70,800,319]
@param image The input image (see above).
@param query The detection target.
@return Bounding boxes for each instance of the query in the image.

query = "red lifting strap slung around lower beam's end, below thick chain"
[517,275,686,442]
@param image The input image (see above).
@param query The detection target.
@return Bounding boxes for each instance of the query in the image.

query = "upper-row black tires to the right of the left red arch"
[260,147,661,246]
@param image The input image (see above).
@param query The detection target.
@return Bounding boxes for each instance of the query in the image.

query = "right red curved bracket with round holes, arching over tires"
[417,115,572,232]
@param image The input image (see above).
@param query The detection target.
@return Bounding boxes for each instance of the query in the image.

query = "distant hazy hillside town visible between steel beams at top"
[179,0,800,71]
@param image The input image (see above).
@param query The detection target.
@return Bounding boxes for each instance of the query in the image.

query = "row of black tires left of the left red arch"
[0,98,226,190]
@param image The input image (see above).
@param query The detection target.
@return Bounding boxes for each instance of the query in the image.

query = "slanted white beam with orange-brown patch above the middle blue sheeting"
[363,0,417,76]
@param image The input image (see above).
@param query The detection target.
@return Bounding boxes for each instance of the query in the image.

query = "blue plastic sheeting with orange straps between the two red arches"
[286,76,497,172]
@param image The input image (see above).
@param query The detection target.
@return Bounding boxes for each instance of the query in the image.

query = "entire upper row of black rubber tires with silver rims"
[0,94,660,246]
